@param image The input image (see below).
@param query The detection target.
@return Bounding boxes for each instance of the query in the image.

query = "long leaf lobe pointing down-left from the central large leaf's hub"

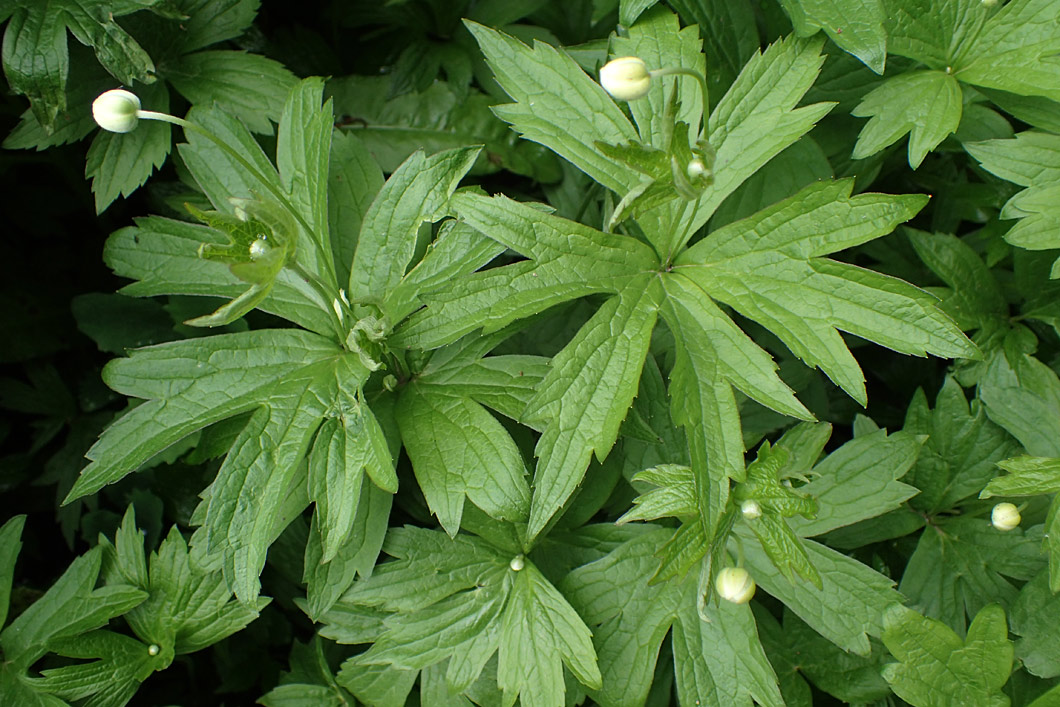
[524,276,660,538]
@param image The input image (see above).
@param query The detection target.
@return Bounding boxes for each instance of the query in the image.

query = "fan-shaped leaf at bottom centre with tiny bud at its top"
[323,527,601,706]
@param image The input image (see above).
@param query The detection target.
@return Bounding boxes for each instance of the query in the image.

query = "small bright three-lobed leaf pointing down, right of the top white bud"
[851,71,961,170]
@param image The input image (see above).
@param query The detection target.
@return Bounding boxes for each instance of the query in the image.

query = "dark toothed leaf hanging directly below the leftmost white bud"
[85,85,172,213]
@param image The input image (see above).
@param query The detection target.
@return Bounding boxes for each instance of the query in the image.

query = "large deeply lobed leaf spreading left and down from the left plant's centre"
[69,330,396,602]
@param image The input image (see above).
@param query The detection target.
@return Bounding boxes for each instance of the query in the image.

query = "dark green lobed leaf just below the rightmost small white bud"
[899,516,1044,633]
